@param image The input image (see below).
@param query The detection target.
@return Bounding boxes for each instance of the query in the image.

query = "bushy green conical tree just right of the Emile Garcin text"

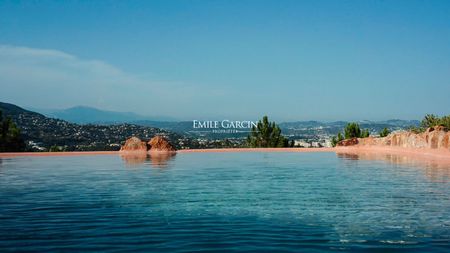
[247,116,289,148]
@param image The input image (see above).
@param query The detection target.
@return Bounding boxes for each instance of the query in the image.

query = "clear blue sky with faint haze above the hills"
[0,1,450,120]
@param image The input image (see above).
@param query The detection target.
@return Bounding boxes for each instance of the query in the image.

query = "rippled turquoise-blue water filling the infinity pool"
[0,153,450,252]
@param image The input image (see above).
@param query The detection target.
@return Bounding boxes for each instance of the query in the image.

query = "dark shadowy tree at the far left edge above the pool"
[0,111,25,152]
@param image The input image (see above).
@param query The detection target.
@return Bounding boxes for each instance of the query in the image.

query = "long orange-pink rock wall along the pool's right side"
[337,126,450,151]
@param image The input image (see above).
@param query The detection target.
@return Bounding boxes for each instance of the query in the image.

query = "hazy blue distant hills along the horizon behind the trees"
[29,106,419,141]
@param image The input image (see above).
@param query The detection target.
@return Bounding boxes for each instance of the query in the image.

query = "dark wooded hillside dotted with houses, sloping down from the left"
[0,102,190,151]
